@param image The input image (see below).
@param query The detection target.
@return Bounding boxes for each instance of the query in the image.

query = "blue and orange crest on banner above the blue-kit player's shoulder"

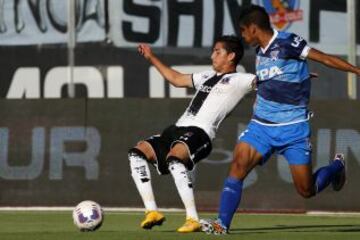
[257,0,303,31]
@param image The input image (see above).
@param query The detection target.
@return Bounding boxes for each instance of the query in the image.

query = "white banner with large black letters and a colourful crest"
[109,0,360,54]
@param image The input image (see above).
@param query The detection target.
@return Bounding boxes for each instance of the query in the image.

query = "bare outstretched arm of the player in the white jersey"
[138,44,193,87]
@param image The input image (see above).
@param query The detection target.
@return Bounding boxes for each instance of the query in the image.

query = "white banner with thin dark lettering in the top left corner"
[0,0,106,45]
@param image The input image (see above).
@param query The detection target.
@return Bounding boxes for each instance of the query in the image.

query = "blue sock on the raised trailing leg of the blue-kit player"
[313,161,344,193]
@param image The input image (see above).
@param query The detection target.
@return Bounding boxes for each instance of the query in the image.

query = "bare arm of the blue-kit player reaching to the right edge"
[308,48,360,75]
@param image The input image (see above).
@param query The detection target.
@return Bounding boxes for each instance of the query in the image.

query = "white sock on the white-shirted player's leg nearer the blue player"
[169,161,199,221]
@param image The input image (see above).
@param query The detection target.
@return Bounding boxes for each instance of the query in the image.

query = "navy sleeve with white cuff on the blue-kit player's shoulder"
[285,33,310,60]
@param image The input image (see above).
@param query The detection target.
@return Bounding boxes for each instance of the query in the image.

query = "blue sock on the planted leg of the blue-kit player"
[219,177,243,229]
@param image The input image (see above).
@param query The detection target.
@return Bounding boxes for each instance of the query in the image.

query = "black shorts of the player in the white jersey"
[145,125,212,174]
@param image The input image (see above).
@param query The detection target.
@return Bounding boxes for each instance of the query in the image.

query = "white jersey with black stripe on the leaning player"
[175,71,255,139]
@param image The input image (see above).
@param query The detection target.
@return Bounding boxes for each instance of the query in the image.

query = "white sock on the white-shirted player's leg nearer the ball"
[128,153,157,211]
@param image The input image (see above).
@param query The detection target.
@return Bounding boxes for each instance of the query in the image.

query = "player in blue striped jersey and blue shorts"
[202,5,360,234]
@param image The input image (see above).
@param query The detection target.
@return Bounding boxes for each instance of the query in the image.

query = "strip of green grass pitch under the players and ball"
[0,211,360,240]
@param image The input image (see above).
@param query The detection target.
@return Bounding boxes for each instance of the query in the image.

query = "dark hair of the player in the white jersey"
[214,35,244,66]
